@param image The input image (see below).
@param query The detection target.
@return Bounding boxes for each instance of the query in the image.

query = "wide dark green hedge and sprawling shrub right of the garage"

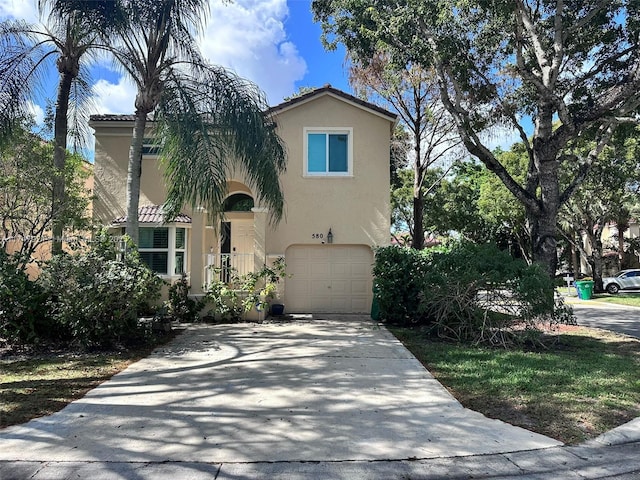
[374,241,574,345]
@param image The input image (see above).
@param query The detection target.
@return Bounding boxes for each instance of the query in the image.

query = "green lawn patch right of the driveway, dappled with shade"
[388,327,640,444]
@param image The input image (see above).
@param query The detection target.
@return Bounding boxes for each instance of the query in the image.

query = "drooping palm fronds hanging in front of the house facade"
[156,66,286,226]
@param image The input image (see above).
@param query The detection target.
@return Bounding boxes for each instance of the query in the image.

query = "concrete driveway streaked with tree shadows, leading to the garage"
[0,316,560,462]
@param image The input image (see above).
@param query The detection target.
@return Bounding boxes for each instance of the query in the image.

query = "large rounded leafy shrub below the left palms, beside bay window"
[39,233,163,347]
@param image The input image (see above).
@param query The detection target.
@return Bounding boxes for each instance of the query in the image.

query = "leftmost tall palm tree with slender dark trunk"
[0,0,118,254]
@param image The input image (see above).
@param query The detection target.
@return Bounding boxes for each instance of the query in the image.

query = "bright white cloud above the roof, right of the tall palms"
[200,0,307,105]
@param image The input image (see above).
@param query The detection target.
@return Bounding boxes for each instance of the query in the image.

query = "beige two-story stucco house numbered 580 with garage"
[91,86,397,313]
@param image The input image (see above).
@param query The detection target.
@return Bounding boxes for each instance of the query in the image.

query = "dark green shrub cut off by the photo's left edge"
[0,249,46,343]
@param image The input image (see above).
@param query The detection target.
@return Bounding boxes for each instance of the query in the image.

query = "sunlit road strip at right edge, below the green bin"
[571,300,640,338]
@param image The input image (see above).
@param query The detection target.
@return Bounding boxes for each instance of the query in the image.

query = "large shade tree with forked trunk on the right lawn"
[312,0,640,274]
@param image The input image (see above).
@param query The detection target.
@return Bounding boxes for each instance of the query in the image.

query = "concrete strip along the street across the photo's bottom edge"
[0,443,640,480]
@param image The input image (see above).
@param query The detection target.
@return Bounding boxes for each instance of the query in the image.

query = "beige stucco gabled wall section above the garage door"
[267,91,391,254]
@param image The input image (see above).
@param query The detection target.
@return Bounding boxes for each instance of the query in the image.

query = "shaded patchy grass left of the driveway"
[0,335,173,428]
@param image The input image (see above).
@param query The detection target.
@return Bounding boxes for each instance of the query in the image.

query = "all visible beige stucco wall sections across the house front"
[92,91,392,300]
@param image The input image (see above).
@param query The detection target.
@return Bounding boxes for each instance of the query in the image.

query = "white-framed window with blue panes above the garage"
[304,128,353,176]
